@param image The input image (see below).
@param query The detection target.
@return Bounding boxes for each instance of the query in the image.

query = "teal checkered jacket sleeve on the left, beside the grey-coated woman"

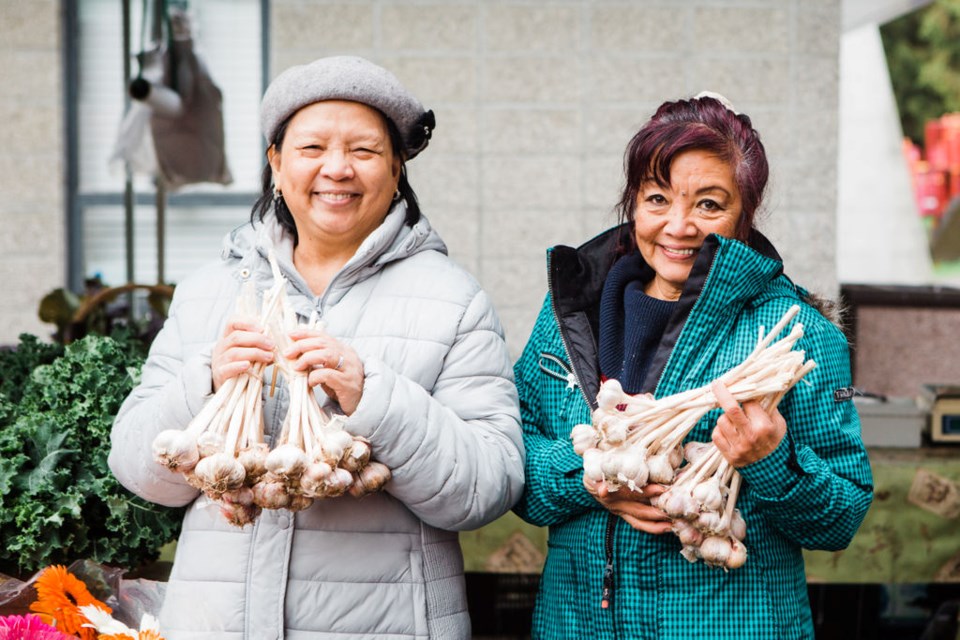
[514,296,600,526]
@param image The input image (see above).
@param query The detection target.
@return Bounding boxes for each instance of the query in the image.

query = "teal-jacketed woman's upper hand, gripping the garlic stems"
[712,380,787,468]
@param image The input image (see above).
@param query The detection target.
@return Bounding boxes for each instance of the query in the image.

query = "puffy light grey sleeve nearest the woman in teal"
[347,290,523,531]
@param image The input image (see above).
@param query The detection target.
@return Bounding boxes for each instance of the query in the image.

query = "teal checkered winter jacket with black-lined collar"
[515,226,873,640]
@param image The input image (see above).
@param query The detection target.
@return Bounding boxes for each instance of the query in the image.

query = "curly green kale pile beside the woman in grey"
[0,334,183,575]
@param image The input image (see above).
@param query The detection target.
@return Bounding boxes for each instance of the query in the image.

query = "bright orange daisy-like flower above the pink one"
[30,565,113,640]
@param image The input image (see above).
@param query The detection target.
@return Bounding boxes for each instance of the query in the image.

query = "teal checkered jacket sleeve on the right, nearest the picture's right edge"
[740,314,873,551]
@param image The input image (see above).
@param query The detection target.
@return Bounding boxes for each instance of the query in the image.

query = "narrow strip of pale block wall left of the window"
[0,0,66,344]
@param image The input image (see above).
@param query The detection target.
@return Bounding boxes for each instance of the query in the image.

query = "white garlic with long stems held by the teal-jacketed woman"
[570,306,816,570]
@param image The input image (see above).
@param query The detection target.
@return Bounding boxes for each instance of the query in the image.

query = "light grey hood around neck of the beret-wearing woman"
[221,202,447,304]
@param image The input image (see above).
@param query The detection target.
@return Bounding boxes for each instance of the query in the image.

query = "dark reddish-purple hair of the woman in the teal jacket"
[617,96,770,240]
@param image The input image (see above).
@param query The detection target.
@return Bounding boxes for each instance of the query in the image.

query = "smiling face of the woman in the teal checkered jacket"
[634,150,741,300]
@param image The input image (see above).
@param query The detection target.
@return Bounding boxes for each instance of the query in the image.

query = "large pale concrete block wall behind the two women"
[270,0,840,355]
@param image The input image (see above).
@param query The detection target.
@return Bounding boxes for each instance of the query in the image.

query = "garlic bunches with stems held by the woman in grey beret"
[153,256,390,526]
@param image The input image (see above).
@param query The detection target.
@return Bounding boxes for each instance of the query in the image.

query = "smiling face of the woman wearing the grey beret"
[267,100,400,252]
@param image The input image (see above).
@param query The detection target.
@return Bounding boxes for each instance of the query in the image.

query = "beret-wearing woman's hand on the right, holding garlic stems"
[283,329,364,416]
